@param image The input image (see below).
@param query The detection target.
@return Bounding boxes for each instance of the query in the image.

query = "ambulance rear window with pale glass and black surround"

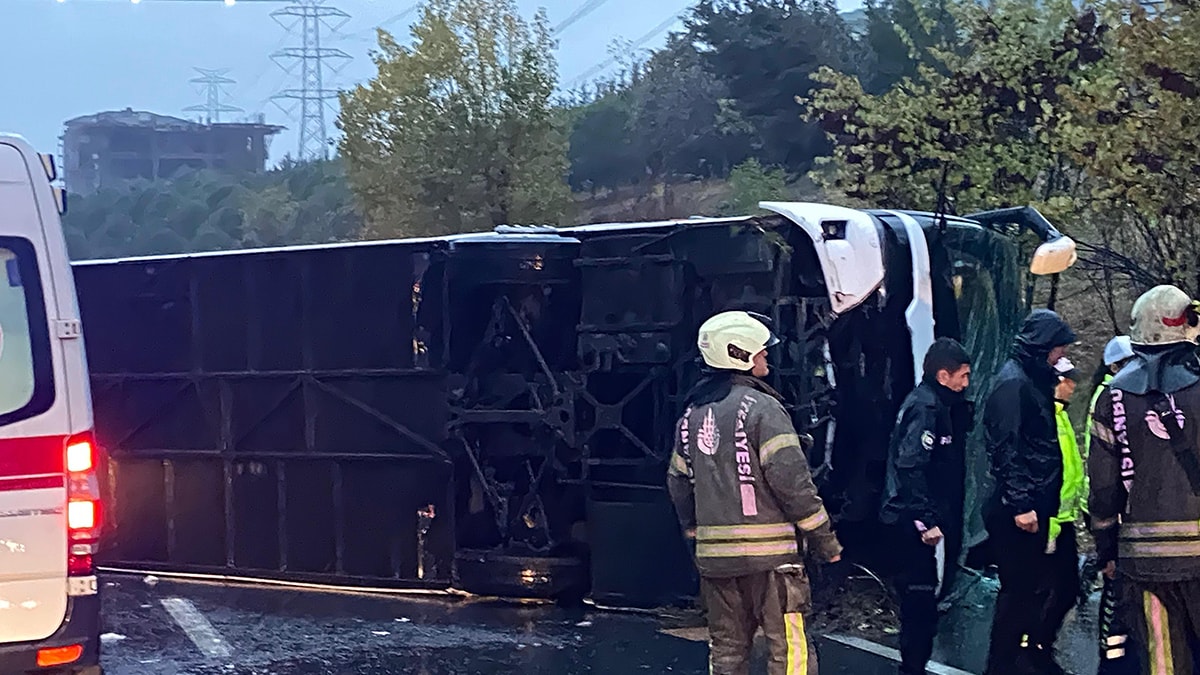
[0,237,54,425]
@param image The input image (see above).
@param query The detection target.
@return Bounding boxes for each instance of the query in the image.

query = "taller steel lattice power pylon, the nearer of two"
[270,0,352,160]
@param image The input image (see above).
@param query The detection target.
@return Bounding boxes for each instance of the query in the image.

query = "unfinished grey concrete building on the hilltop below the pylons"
[62,108,283,195]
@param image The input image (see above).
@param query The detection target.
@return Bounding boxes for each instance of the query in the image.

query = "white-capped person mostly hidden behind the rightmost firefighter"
[1084,335,1139,675]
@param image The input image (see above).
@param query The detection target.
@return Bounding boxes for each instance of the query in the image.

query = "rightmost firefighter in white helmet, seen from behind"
[1088,281,1200,675]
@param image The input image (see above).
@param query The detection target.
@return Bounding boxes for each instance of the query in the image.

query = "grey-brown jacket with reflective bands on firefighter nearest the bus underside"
[667,375,841,577]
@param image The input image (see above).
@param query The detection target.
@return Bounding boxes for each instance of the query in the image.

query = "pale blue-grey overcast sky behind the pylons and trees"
[0,0,860,160]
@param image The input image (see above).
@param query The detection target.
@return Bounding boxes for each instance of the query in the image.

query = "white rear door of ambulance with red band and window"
[0,137,73,643]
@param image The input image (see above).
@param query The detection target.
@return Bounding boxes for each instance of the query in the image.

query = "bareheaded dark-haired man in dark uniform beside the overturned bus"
[880,338,971,675]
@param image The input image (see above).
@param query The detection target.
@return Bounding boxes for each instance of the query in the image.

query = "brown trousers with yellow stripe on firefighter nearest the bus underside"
[700,565,817,675]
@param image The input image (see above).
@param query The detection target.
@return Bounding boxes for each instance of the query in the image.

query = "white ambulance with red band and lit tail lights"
[0,135,101,675]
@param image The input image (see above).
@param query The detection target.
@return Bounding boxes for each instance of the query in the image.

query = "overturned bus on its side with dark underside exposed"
[74,203,1075,607]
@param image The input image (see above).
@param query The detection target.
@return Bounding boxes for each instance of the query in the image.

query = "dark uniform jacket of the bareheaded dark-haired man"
[880,378,966,532]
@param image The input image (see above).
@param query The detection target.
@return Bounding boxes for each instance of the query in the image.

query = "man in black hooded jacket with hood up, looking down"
[983,310,1075,675]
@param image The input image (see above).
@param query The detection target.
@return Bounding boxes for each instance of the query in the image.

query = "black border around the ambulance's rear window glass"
[0,235,56,428]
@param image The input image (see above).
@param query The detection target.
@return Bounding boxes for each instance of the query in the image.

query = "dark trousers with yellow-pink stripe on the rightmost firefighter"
[1121,577,1200,675]
